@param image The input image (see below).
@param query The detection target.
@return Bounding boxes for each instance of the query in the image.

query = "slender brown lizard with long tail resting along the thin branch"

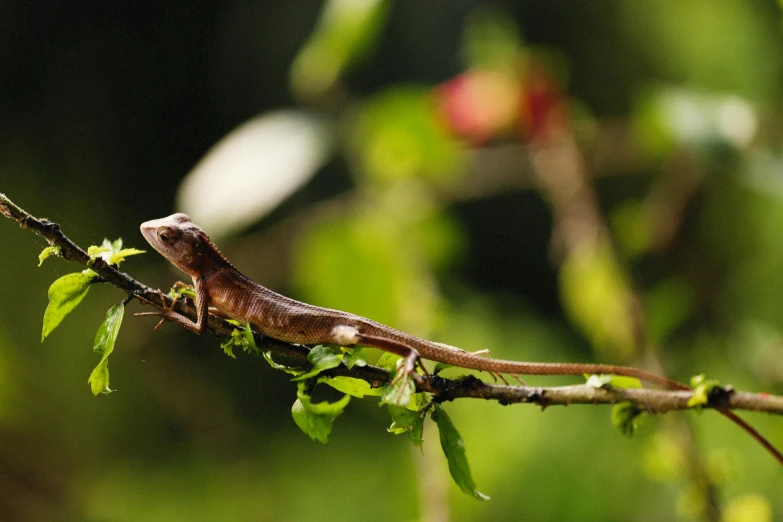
[136,213,690,390]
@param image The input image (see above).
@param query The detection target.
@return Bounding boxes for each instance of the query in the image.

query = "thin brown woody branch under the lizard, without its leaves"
[0,193,783,415]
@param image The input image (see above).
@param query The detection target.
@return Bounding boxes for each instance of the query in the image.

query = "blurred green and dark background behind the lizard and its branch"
[0,0,783,522]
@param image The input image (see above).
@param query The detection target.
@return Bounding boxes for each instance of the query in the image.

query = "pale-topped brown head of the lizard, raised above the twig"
[141,213,214,278]
